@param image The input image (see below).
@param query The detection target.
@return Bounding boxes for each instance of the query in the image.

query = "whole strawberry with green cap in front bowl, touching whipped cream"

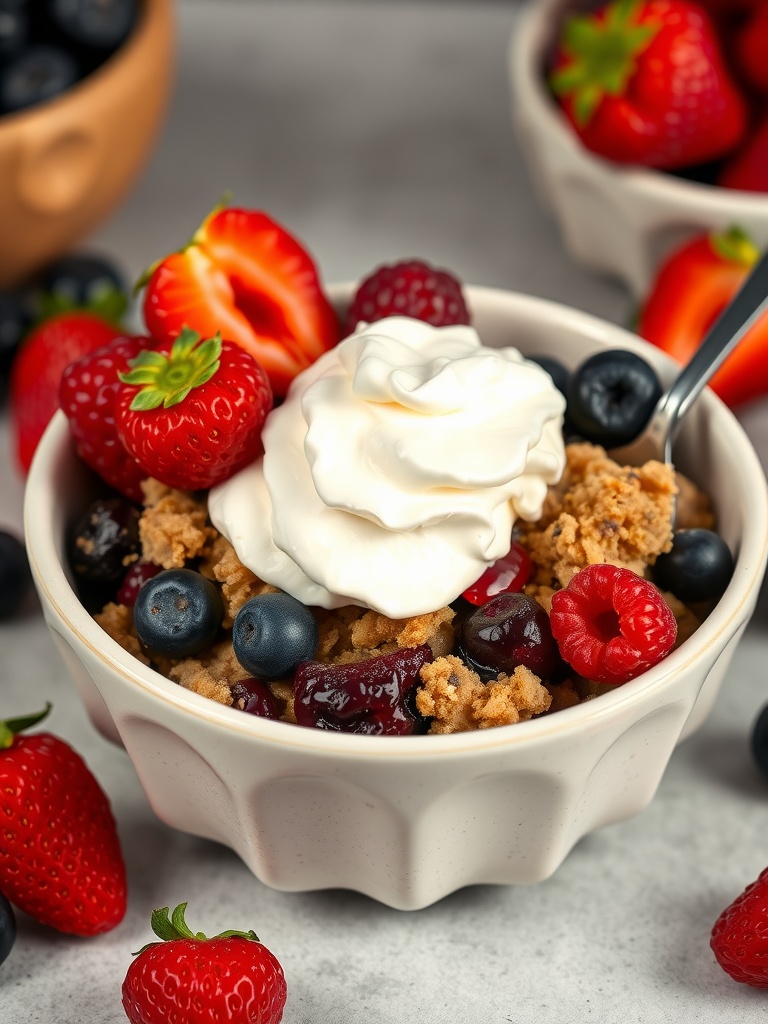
[115,328,272,490]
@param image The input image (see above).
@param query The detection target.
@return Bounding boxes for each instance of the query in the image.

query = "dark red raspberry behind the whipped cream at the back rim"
[346,259,470,334]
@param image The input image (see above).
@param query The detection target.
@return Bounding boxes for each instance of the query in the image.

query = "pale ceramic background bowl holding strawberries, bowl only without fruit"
[509,0,768,298]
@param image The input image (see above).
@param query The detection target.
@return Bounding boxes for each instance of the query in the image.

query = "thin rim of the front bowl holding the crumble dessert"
[24,283,768,762]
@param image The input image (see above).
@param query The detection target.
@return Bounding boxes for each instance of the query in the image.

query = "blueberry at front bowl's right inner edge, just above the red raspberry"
[651,529,733,601]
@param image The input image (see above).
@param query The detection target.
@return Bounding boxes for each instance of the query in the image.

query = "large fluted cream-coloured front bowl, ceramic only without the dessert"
[25,288,768,909]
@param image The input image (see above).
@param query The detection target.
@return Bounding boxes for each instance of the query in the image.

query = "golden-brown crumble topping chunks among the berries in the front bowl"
[94,443,715,734]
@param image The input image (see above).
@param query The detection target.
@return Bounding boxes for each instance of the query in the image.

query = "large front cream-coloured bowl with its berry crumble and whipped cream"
[25,203,768,909]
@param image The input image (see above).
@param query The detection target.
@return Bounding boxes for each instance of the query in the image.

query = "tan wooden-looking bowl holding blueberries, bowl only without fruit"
[0,0,174,288]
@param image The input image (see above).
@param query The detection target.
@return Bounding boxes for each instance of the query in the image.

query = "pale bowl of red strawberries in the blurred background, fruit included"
[509,0,768,297]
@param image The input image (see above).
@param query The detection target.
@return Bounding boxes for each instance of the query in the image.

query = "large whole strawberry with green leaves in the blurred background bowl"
[550,0,746,170]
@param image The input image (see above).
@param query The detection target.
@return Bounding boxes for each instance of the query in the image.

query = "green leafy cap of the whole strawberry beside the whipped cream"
[118,327,221,412]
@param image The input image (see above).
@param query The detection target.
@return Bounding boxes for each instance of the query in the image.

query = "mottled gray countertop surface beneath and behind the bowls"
[0,0,768,1024]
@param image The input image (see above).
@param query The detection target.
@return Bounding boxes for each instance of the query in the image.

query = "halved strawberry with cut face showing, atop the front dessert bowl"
[144,208,339,395]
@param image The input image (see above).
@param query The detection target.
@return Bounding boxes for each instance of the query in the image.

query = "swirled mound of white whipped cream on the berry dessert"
[209,316,565,618]
